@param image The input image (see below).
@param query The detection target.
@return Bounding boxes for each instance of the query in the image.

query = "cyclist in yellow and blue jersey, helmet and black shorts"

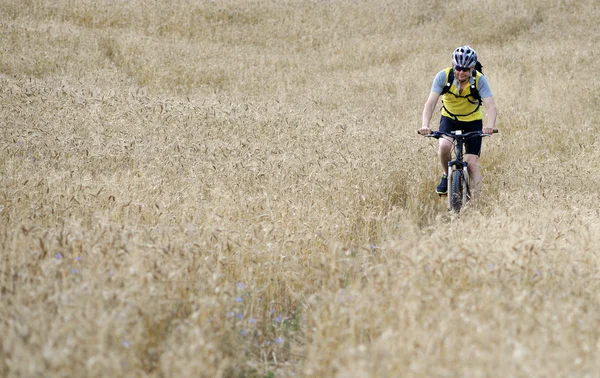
[419,45,497,196]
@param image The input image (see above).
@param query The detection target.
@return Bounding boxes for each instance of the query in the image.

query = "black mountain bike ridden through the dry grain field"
[424,129,498,213]
